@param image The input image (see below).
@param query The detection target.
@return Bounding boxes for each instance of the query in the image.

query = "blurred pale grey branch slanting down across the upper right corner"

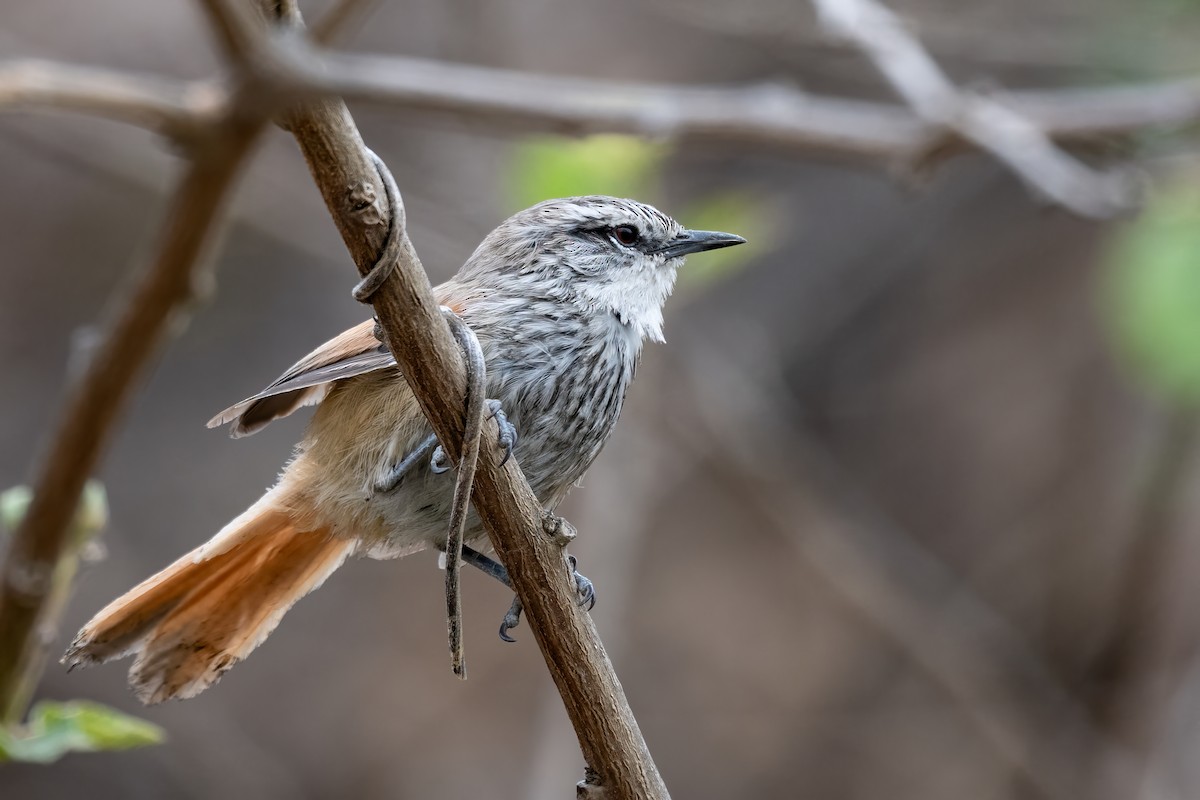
[812,0,1136,217]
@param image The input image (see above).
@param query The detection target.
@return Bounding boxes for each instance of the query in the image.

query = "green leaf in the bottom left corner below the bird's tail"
[0,700,164,764]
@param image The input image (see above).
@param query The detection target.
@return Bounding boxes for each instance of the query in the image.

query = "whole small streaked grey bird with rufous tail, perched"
[62,196,745,704]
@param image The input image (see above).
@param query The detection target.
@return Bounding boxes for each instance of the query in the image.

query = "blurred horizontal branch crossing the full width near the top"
[0,52,1200,185]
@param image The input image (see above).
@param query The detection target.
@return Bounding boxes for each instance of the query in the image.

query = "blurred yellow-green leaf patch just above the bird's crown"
[509,134,667,209]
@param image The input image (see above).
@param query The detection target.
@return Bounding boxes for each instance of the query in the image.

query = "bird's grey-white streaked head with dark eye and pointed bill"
[460,194,745,341]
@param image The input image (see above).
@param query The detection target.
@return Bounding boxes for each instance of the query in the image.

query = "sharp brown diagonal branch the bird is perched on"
[258,2,668,800]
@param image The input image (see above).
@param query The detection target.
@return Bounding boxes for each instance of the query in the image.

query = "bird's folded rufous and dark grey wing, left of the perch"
[209,319,396,438]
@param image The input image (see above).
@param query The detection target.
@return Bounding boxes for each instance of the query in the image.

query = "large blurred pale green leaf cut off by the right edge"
[1104,175,1200,405]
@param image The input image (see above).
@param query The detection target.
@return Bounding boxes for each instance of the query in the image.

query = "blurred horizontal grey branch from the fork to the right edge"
[298,53,1200,170]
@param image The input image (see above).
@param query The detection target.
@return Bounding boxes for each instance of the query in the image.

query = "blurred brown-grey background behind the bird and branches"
[0,0,1200,800]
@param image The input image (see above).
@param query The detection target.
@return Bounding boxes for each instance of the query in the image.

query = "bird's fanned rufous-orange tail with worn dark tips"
[62,489,354,704]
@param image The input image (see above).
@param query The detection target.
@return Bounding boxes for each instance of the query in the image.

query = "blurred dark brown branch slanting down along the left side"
[0,115,263,721]
